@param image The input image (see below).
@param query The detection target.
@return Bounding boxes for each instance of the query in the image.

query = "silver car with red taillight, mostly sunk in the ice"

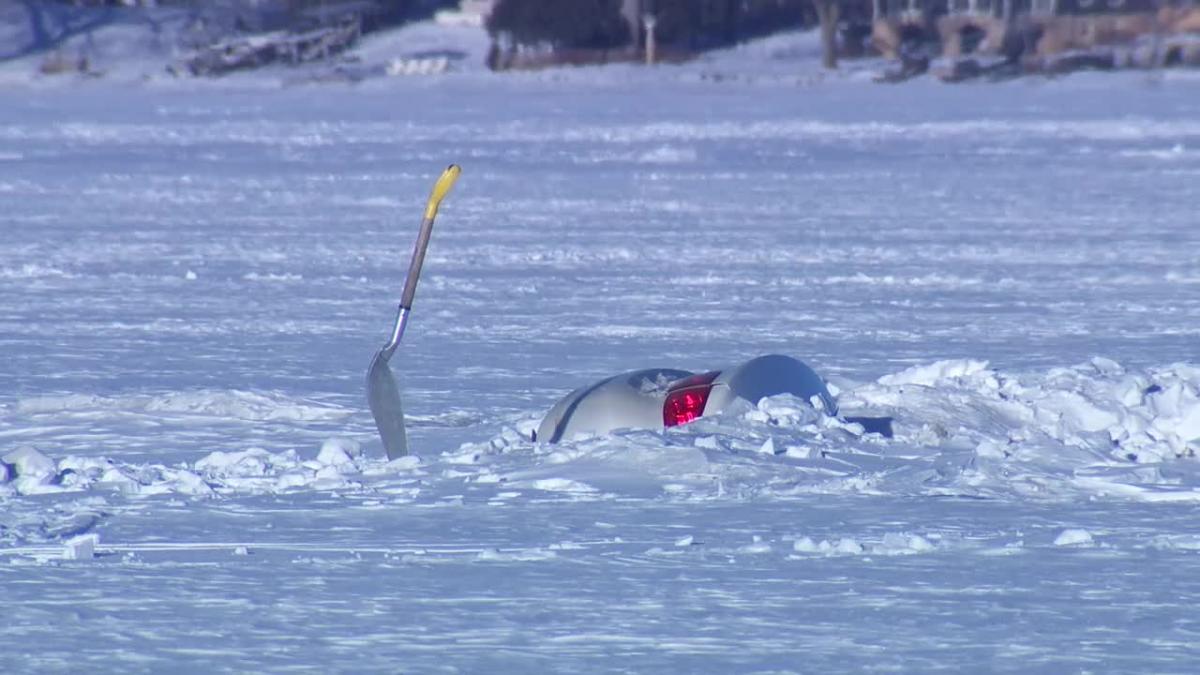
[533,354,892,443]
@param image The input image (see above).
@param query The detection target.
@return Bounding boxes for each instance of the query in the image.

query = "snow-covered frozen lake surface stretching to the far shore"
[0,23,1200,673]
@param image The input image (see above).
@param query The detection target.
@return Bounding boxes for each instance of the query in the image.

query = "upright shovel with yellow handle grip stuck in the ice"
[367,165,462,459]
